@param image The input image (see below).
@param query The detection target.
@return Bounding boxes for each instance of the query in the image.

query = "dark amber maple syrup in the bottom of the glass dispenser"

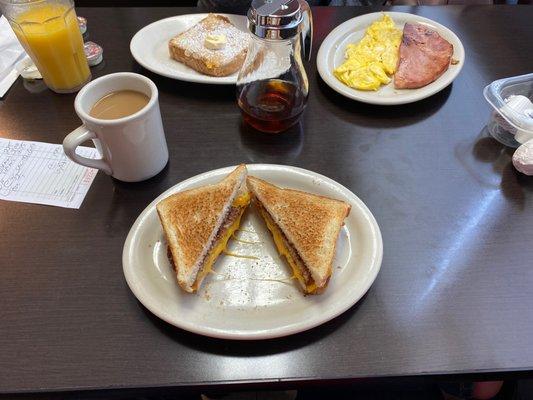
[238,79,307,133]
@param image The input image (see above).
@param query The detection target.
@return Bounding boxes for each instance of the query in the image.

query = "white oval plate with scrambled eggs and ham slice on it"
[317,12,465,105]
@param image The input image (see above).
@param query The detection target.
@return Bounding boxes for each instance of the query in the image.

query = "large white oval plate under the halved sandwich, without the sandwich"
[122,164,383,339]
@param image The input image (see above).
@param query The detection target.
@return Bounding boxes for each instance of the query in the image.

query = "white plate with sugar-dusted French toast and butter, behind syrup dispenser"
[130,14,249,85]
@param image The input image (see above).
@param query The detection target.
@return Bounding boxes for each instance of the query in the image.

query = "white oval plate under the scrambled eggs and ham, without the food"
[317,11,465,105]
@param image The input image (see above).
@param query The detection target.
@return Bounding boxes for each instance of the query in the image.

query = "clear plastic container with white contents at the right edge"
[483,73,533,147]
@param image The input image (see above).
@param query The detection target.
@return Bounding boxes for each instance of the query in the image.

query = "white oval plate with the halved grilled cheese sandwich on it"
[123,164,383,340]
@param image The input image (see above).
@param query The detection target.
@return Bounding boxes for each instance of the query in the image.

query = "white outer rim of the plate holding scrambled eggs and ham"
[317,11,465,105]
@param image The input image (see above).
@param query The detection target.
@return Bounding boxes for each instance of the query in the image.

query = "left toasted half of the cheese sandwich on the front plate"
[157,164,250,292]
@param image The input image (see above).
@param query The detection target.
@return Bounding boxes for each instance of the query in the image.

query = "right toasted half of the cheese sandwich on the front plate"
[247,176,351,294]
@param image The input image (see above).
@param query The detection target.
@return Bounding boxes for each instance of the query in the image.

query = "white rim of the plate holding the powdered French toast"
[130,13,245,85]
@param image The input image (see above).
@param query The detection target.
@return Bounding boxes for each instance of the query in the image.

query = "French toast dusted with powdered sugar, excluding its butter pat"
[168,14,249,76]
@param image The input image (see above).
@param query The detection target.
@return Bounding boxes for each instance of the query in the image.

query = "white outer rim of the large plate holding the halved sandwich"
[122,164,383,340]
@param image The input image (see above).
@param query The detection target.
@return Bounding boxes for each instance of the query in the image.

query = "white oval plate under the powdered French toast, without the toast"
[130,14,248,85]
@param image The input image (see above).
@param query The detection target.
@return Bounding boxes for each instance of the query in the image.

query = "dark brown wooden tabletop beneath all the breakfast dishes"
[0,6,533,398]
